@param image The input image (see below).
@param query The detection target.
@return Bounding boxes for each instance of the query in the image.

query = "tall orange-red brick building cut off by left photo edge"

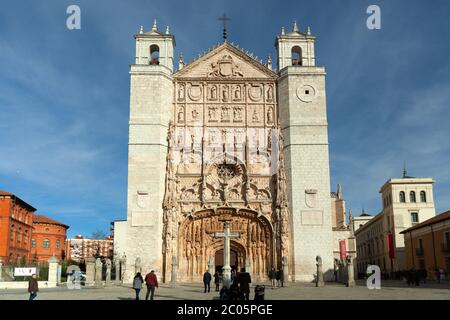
[0,190,36,263]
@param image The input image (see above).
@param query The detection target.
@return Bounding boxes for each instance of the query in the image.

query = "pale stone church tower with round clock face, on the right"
[275,22,334,281]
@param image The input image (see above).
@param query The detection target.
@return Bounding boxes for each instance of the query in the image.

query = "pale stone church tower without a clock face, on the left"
[126,20,175,282]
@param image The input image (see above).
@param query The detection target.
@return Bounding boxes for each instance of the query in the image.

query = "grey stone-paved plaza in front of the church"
[0,281,450,300]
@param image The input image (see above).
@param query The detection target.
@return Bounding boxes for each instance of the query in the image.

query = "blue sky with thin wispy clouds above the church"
[0,0,450,236]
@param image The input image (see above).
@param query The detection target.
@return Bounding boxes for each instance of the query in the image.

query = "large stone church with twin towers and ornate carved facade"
[118,21,342,282]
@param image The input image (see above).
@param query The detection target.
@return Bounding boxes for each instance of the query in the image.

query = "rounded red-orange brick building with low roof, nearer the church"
[31,214,69,261]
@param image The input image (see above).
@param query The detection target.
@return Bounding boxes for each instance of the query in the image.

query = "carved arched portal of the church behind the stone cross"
[178,207,275,281]
